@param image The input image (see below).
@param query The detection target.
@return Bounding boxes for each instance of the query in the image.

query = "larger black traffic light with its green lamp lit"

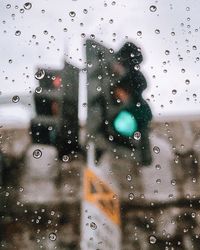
[86,40,152,165]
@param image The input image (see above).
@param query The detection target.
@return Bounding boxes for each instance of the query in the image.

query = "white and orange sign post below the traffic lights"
[81,160,121,250]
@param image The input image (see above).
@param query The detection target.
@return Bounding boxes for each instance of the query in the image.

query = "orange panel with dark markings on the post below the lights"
[84,168,120,225]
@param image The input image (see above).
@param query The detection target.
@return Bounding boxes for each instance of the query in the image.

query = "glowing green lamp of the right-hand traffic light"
[113,110,137,137]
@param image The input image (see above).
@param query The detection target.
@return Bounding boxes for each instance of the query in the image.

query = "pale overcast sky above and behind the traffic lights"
[0,0,200,121]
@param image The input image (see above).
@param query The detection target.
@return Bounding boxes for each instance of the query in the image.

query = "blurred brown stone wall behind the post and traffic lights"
[0,119,200,250]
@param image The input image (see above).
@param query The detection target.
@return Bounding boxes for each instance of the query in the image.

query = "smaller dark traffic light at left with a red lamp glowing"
[31,63,79,158]
